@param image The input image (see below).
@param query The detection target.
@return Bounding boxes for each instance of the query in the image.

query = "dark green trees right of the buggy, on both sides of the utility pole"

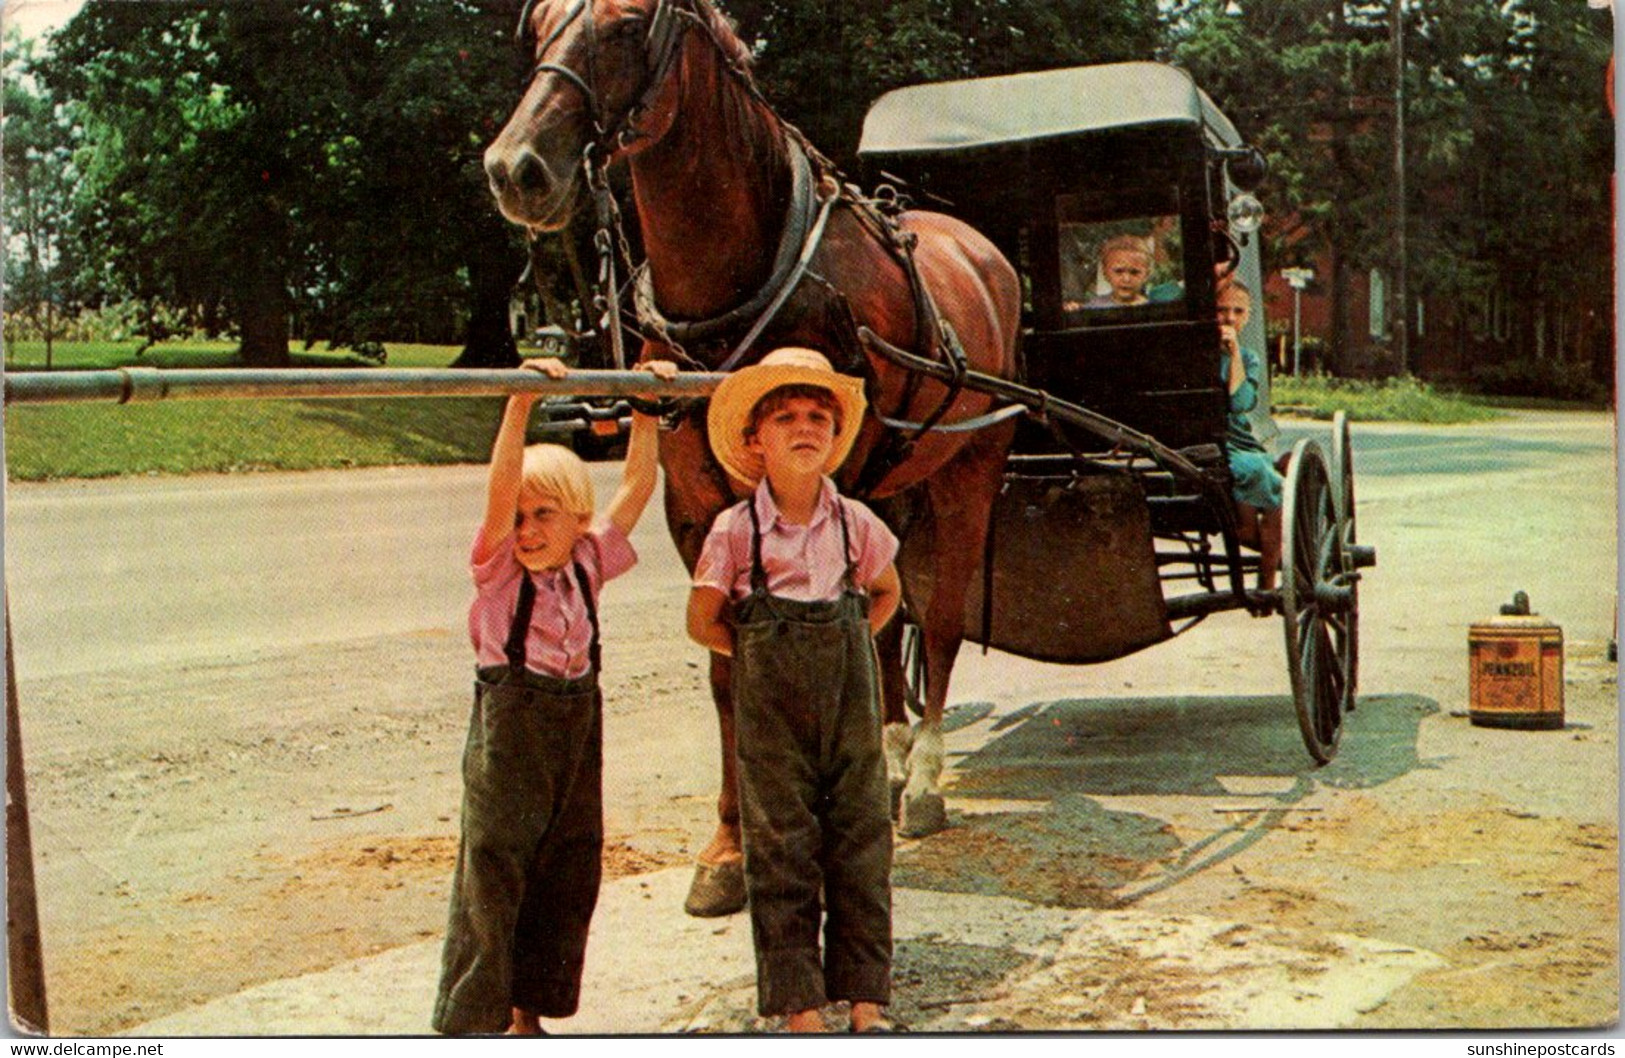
[1168,0,1614,377]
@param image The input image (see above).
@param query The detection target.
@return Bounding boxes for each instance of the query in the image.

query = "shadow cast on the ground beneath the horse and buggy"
[892,696,1438,908]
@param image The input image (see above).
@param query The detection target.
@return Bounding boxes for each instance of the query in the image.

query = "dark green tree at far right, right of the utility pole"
[1411,0,1614,382]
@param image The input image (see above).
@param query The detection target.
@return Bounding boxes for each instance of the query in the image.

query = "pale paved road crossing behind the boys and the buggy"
[5,414,1614,678]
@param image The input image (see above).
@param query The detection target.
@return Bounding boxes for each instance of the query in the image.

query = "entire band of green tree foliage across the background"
[5,0,1612,385]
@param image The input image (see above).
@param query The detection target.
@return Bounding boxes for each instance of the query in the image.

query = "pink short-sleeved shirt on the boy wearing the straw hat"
[694,478,897,603]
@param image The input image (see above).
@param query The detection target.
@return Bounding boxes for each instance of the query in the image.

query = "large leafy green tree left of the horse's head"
[42,0,525,364]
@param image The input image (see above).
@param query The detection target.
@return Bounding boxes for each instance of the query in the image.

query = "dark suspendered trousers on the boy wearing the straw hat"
[733,499,892,1016]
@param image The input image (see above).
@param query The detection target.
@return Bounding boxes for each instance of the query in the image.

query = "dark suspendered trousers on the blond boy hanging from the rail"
[434,562,603,1034]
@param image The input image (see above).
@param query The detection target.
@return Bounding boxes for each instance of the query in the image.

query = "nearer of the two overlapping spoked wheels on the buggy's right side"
[1281,437,1359,764]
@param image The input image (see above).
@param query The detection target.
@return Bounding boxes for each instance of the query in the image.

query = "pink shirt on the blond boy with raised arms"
[468,522,637,679]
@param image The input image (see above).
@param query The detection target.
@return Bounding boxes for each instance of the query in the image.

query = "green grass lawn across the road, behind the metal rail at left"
[5,341,502,481]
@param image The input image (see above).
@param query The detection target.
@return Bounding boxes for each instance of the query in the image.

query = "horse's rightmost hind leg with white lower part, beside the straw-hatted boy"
[897,426,1014,837]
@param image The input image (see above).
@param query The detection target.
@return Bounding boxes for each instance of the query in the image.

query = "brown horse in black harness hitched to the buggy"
[486,0,1021,915]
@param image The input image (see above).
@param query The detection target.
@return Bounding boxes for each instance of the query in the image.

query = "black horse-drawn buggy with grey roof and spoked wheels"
[860,62,1375,762]
